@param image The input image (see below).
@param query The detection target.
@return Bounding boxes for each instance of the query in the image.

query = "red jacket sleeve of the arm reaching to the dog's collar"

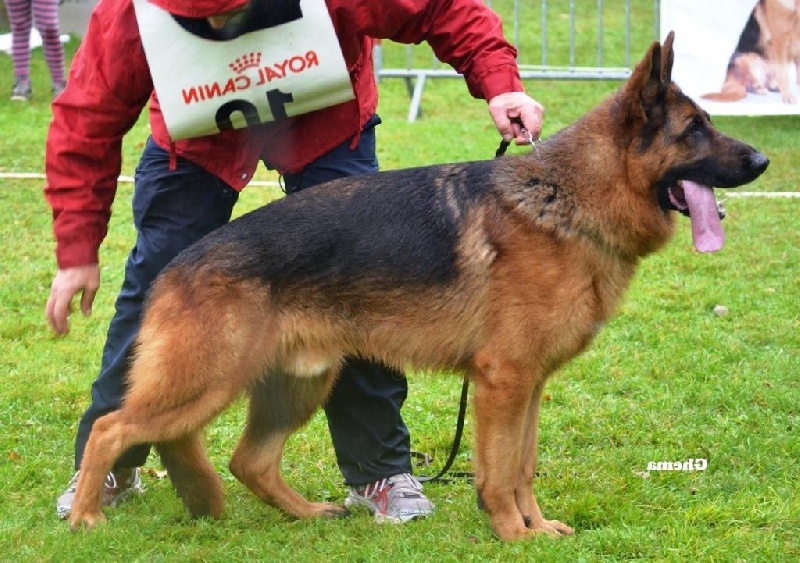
[328,0,523,100]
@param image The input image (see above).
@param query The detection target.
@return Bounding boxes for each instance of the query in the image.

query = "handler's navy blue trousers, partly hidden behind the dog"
[75,116,411,485]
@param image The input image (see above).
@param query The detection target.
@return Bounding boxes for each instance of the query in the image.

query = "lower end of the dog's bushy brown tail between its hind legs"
[156,431,225,518]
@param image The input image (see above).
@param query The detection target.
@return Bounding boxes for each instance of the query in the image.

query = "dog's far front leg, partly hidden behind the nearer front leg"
[515,380,574,536]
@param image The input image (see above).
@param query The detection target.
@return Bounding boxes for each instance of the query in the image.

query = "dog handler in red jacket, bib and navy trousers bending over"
[45,0,543,522]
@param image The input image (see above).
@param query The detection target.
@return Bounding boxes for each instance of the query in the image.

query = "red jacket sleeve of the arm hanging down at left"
[44,0,153,268]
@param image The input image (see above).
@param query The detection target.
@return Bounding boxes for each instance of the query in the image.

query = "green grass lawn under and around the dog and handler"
[0,9,800,562]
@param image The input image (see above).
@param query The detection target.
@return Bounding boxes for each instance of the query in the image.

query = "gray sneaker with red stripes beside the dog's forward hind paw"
[344,473,433,524]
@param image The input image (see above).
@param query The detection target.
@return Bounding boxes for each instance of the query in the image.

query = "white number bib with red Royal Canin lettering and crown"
[134,0,355,140]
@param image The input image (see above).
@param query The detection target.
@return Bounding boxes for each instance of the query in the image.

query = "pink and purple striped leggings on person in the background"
[6,0,65,84]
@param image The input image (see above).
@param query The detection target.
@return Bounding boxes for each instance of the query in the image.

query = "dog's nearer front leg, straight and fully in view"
[474,357,535,540]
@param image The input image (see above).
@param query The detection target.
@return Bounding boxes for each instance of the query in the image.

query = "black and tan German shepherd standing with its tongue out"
[70,34,768,540]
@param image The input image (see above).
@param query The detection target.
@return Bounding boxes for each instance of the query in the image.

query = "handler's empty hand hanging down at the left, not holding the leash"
[45,264,100,334]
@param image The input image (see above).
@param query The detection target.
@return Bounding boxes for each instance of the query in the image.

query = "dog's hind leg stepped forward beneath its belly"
[230,369,347,518]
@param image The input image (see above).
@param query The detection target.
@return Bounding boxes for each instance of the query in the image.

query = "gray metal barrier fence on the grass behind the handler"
[374,0,660,122]
